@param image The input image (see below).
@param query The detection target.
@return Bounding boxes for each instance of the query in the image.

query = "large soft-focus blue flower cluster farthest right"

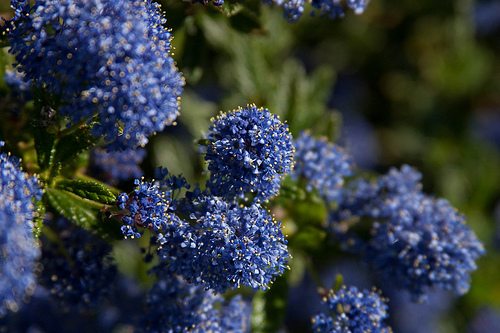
[367,193,484,299]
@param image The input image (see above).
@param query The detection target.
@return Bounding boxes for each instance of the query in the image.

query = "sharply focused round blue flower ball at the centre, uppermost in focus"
[205,105,294,201]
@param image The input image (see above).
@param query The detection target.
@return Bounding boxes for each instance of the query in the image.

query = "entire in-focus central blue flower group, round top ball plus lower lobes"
[117,106,294,292]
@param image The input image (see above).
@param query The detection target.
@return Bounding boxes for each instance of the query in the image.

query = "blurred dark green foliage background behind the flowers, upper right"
[1,0,500,332]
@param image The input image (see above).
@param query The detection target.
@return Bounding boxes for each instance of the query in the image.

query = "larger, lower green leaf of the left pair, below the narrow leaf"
[45,188,123,240]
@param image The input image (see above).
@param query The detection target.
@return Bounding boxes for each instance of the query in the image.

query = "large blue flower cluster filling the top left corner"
[9,0,184,149]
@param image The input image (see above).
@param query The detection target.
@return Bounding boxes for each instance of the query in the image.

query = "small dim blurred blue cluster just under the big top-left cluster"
[90,148,146,184]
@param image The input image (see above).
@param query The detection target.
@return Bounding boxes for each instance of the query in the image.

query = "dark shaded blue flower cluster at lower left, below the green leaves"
[39,218,117,309]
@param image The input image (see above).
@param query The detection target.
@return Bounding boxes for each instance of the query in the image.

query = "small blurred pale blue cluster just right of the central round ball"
[292,132,353,202]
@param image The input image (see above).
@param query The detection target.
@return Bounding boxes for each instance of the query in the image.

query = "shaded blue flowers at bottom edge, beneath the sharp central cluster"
[144,272,250,333]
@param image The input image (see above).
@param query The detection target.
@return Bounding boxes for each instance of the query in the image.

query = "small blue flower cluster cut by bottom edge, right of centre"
[312,286,391,333]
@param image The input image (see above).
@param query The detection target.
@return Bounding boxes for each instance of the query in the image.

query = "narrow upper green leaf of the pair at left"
[56,179,116,205]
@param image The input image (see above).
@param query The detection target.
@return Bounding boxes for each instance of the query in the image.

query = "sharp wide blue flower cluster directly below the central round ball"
[167,196,288,292]
